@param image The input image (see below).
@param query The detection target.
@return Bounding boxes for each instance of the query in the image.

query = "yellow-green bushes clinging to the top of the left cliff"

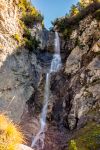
[18,0,43,51]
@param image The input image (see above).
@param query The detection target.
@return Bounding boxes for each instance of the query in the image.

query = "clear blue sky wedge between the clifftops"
[31,0,78,29]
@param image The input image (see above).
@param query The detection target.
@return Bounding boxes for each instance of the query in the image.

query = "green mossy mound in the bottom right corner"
[69,122,100,150]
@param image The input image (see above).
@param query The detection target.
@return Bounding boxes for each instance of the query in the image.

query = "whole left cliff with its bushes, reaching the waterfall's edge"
[0,0,54,122]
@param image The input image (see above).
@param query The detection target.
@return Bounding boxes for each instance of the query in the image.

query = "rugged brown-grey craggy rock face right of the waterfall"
[51,15,100,129]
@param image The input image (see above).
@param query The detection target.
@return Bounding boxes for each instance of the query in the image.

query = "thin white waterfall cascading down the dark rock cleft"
[31,32,61,150]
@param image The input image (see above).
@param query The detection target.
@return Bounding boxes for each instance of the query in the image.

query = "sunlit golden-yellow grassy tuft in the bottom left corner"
[0,114,24,150]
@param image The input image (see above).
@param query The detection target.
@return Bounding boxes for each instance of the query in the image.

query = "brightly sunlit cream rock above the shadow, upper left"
[0,0,20,63]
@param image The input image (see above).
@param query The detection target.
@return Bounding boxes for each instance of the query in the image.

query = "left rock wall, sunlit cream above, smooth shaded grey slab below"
[0,0,42,122]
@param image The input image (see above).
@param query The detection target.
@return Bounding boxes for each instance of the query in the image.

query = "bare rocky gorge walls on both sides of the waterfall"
[0,0,100,150]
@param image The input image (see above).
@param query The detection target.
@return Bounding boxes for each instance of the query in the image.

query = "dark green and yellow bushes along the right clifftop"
[52,0,100,39]
